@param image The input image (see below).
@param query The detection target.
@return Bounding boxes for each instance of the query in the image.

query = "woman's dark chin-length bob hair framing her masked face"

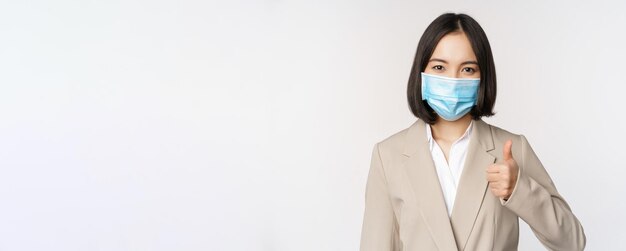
[407,13,496,125]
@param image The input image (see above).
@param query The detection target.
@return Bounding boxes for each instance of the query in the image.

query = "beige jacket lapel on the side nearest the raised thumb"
[450,120,496,250]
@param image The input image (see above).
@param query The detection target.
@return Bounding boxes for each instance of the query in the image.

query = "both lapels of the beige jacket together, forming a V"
[403,119,495,250]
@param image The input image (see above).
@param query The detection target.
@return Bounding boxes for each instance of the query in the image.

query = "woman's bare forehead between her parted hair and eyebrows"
[431,32,476,63]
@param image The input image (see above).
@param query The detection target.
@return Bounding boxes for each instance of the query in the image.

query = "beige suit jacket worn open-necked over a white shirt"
[361,119,586,251]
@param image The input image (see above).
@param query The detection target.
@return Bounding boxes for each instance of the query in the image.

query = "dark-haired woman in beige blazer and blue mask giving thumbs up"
[361,13,586,251]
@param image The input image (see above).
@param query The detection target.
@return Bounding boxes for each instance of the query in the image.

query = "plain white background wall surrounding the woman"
[0,0,626,251]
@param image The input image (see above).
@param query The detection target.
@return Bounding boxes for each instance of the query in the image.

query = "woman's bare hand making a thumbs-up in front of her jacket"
[487,139,519,200]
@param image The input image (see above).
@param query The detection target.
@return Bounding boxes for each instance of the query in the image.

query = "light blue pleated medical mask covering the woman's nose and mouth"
[422,72,480,121]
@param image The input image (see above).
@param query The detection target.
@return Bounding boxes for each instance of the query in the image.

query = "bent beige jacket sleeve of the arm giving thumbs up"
[500,135,586,250]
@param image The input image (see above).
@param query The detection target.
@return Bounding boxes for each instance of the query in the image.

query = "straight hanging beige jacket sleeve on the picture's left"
[360,144,400,251]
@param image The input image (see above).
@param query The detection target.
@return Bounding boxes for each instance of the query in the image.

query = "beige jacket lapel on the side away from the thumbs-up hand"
[403,119,458,250]
